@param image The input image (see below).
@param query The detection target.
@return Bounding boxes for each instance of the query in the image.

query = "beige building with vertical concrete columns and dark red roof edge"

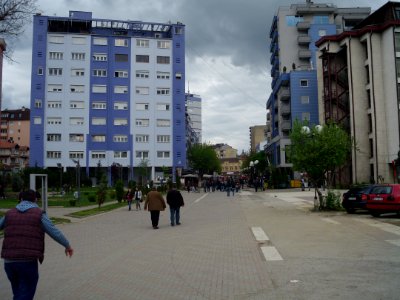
[316,2,400,183]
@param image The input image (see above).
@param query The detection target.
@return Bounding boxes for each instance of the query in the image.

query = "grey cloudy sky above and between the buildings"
[2,0,387,153]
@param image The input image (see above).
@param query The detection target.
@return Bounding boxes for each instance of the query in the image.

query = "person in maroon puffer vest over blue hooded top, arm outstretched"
[0,190,74,299]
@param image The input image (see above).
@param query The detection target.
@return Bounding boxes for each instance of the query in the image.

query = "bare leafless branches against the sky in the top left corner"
[0,0,38,59]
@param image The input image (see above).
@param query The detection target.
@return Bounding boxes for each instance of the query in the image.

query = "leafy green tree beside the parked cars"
[288,120,352,209]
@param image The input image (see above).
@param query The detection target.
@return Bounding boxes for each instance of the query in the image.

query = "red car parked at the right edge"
[367,184,400,217]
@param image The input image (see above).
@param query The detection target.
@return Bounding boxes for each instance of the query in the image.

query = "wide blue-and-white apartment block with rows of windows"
[30,11,186,180]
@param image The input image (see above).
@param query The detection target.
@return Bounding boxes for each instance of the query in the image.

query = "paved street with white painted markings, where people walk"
[0,190,400,300]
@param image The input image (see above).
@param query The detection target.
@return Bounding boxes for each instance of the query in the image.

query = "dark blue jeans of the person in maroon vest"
[4,260,39,300]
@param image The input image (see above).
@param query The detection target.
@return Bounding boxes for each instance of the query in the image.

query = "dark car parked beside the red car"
[342,185,375,214]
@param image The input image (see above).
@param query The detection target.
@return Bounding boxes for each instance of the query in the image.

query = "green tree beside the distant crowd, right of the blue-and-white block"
[187,144,221,177]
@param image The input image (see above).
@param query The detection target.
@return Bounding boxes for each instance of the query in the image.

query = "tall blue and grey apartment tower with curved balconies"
[264,0,370,172]
